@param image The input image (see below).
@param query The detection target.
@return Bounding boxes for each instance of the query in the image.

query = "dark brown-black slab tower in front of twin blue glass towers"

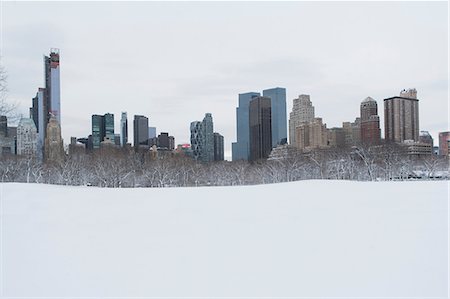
[249,96,272,161]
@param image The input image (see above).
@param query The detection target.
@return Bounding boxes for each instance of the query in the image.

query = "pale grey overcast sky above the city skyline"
[1,1,449,157]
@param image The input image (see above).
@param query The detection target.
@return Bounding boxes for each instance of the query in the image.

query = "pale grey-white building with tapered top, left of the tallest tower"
[17,118,37,156]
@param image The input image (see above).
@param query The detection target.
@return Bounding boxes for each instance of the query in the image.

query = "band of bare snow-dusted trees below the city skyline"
[0,145,449,187]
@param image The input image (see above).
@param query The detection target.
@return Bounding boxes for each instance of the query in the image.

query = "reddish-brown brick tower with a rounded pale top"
[360,97,381,144]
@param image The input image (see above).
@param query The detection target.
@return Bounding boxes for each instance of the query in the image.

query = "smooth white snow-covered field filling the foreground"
[0,181,448,297]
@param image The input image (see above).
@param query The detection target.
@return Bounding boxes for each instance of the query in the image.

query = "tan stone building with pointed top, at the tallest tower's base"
[44,115,64,162]
